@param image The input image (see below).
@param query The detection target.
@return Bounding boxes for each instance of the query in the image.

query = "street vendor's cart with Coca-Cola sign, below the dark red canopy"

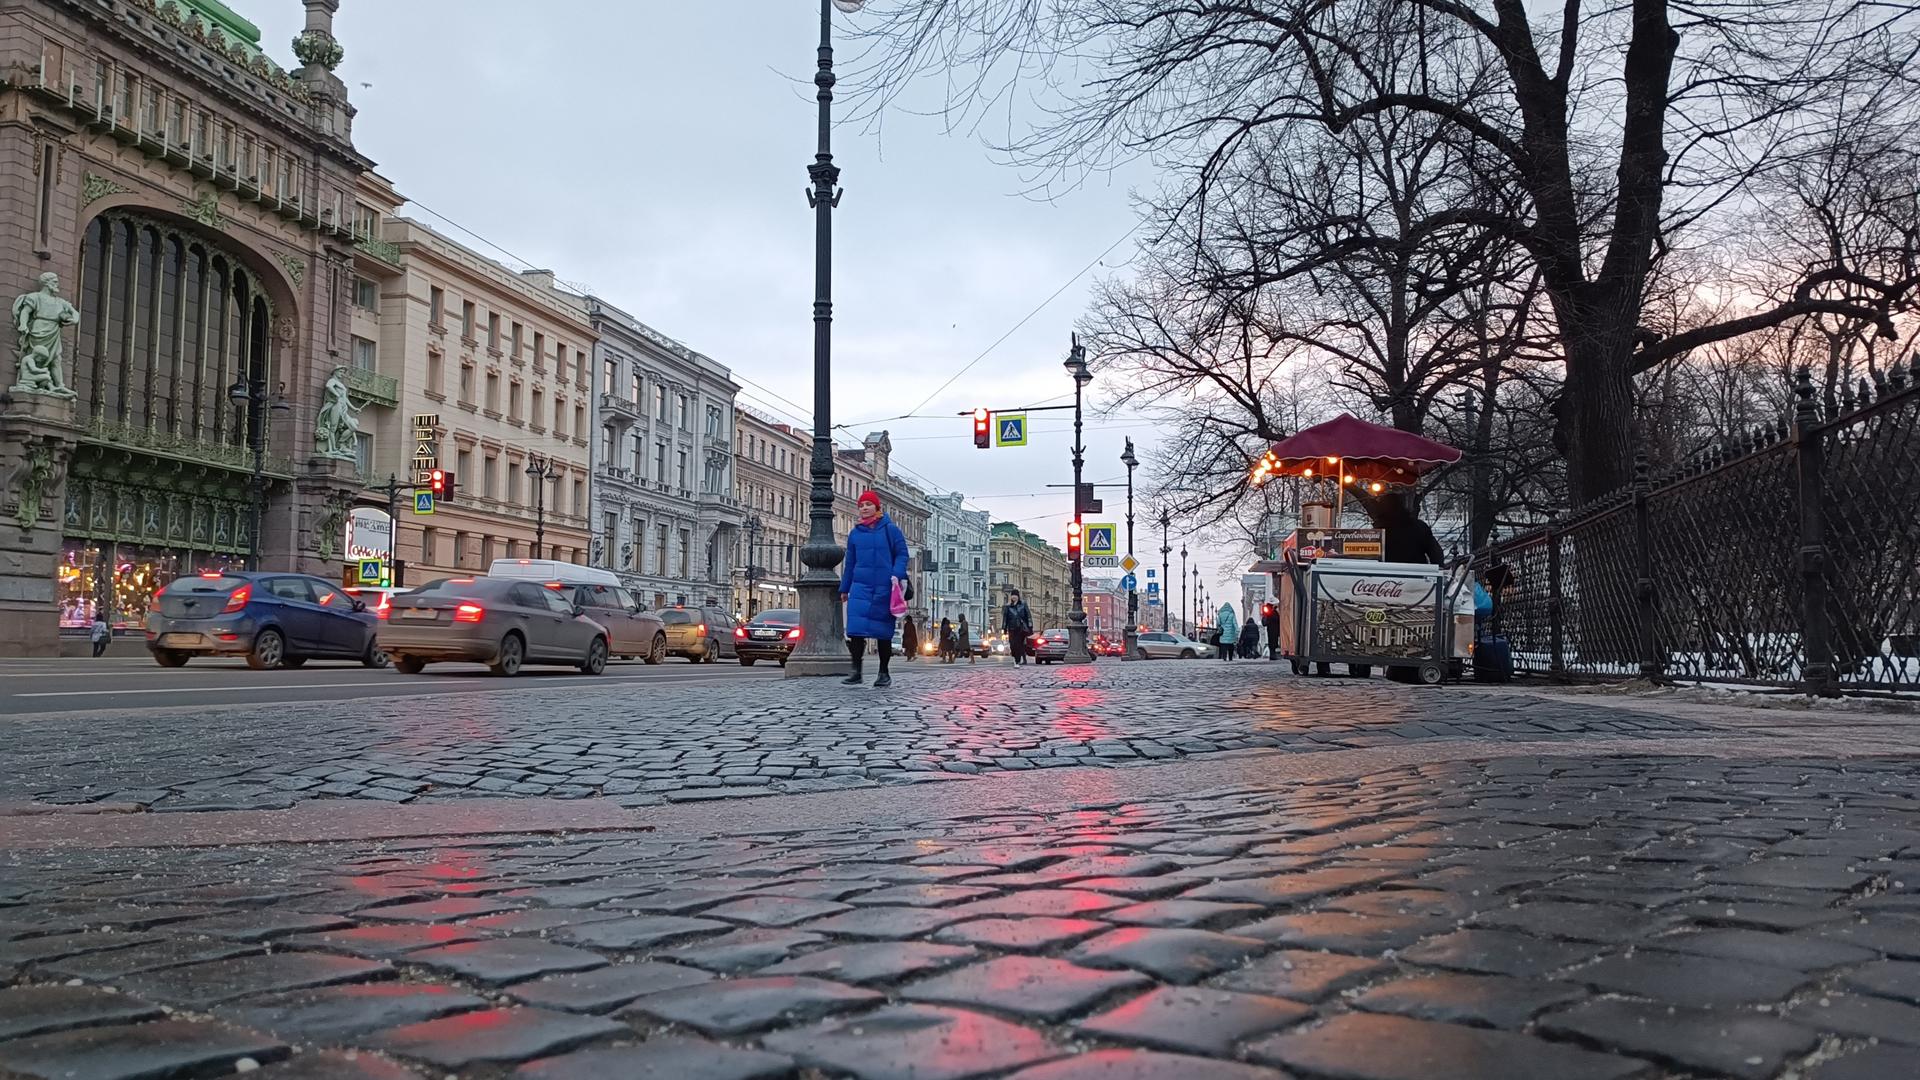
[1281,559,1473,686]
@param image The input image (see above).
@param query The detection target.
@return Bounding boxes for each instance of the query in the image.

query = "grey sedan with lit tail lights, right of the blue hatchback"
[382,578,609,675]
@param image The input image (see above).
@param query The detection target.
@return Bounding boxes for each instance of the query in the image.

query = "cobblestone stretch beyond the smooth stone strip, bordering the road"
[0,661,1707,811]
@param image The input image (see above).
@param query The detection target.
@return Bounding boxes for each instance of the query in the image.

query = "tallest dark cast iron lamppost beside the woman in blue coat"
[785,0,866,678]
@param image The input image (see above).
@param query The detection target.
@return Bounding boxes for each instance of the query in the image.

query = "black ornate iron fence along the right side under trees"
[1476,365,1920,694]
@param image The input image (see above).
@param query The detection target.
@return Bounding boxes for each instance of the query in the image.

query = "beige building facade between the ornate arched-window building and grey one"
[357,212,593,584]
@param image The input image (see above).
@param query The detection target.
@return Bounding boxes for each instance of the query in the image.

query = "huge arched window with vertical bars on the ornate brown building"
[73,211,275,446]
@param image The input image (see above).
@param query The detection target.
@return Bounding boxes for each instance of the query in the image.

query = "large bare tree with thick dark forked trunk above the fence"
[851,0,1920,500]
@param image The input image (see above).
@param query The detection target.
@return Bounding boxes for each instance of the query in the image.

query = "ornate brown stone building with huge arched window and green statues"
[0,0,378,653]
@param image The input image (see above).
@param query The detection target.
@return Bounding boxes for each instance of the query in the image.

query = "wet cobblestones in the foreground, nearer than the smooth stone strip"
[0,757,1920,1080]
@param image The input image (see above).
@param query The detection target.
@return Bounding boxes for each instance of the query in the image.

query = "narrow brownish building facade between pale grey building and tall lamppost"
[733,407,812,617]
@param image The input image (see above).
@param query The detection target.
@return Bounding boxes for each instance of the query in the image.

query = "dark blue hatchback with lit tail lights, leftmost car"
[146,571,386,671]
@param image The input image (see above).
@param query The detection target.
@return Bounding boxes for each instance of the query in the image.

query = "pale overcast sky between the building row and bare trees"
[247,0,1238,614]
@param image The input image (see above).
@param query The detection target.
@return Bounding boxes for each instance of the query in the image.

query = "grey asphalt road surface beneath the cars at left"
[0,657,780,717]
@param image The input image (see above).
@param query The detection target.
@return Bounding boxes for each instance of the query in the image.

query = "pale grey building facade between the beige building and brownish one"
[576,296,745,609]
